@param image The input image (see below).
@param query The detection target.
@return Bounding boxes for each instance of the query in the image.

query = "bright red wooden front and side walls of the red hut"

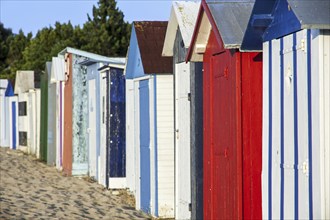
[203,32,262,219]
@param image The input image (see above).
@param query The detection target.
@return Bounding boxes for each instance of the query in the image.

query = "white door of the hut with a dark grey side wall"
[175,63,191,219]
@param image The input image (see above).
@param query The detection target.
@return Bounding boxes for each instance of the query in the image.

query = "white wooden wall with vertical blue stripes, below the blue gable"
[262,30,330,219]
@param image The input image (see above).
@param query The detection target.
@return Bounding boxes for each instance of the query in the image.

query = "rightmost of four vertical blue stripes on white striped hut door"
[307,30,313,219]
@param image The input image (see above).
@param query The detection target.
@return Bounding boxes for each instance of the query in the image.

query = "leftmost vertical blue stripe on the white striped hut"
[268,41,273,219]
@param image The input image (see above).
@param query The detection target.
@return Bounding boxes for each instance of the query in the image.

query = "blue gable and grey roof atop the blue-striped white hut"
[241,0,330,50]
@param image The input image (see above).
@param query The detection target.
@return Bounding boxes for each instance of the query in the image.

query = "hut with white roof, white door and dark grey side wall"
[162,1,203,219]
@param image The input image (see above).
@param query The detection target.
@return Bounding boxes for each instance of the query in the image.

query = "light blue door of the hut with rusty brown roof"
[139,80,150,213]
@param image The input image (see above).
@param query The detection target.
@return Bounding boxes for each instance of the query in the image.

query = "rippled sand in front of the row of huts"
[0,147,151,220]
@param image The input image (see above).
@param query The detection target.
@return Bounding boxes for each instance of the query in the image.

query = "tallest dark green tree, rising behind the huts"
[81,0,131,56]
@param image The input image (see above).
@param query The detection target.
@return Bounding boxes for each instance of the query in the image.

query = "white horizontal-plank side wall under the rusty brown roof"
[156,75,174,218]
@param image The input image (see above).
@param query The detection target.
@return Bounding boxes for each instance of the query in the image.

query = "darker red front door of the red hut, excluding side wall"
[208,51,242,219]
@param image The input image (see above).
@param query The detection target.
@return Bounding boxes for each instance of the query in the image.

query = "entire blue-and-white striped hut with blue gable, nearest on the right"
[242,0,330,219]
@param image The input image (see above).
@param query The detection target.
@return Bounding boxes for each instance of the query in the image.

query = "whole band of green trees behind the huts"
[0,0,131,81]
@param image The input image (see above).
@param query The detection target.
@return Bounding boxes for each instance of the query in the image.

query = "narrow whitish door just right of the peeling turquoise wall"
[88,79,98,179]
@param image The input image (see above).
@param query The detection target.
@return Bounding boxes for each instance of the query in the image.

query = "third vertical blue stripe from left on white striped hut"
[292,33,299,219]
